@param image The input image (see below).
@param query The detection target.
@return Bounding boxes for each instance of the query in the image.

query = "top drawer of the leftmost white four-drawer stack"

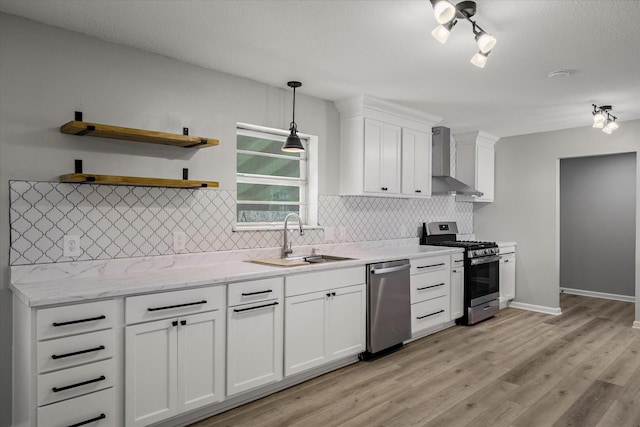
[37,300,118,340]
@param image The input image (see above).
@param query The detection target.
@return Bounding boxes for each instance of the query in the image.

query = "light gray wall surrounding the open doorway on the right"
[474,118,640,321]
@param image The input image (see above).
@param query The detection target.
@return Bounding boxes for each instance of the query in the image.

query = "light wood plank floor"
[193,294,640,427]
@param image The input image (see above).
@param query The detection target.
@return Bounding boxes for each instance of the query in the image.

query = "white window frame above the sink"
[233,123,318,231]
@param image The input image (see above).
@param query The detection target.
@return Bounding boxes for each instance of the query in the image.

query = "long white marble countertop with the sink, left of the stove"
[10,239,462,307]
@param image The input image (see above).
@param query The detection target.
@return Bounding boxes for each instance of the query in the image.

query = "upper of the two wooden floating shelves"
[60,120,220,149]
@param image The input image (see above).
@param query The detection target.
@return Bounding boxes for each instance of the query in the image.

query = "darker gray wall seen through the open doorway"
[560,153,636,296]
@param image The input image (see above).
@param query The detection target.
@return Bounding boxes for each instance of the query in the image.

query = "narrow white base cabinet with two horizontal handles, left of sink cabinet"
[227,277,284,396]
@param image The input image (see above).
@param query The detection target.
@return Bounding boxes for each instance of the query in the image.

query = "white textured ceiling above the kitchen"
[0,0,640,137]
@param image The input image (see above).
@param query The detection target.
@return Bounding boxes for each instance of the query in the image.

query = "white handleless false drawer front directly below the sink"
[284,266,366,297]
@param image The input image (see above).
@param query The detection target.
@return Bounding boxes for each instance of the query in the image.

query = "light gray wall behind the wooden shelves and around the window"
[0,14,339,426]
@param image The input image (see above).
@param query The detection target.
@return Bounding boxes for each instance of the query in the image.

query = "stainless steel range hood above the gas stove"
[431,126,482,197]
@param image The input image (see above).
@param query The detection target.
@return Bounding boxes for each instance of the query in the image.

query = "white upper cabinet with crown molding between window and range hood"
[335,95,440,197]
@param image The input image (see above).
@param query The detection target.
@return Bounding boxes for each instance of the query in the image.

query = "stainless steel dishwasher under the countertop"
[367,259,411,354]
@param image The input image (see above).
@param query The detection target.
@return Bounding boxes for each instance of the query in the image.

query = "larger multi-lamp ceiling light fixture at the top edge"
[430,0,497,68]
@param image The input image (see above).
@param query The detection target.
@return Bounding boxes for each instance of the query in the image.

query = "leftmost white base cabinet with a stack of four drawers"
[12,298,123,427]
